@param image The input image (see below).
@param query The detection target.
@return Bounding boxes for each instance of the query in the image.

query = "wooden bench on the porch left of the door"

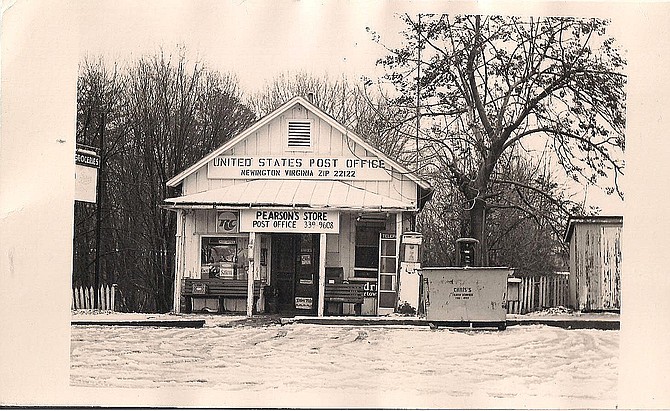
[182,278,262,313]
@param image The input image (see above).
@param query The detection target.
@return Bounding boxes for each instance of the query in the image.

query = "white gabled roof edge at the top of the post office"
[166,96,431,190]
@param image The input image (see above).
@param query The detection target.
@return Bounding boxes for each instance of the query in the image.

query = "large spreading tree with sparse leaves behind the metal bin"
[373,15,626,265]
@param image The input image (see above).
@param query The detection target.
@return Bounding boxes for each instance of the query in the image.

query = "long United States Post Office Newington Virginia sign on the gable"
[207,156,391,181]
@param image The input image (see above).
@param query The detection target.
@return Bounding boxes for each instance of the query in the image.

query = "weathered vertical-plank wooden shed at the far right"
[565,216,623,311]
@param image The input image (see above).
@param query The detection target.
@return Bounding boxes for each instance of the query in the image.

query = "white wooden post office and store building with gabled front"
[164,97,432,316]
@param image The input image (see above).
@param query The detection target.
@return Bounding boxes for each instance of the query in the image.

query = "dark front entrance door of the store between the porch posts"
[272,234,319,315]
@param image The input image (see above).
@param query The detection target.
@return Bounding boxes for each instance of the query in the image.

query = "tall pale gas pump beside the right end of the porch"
[398,232,423,314]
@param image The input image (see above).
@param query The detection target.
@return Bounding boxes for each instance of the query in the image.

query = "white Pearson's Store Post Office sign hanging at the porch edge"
[240,209,340,233]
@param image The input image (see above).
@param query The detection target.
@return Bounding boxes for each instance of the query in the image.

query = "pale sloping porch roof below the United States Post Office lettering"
[165,180,416,210]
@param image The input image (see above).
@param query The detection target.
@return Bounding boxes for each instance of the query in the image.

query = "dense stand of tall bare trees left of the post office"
[75,50,255,312]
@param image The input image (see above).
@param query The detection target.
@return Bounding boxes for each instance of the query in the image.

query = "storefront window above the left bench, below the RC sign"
[200,237,249,280]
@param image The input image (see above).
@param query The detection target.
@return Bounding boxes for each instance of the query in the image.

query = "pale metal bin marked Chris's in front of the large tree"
[422,267,514,329]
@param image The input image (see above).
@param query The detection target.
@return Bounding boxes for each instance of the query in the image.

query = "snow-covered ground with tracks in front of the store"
[70,316,619,408]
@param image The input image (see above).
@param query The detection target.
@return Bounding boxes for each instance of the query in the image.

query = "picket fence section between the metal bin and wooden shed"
[507,273,568,314]
